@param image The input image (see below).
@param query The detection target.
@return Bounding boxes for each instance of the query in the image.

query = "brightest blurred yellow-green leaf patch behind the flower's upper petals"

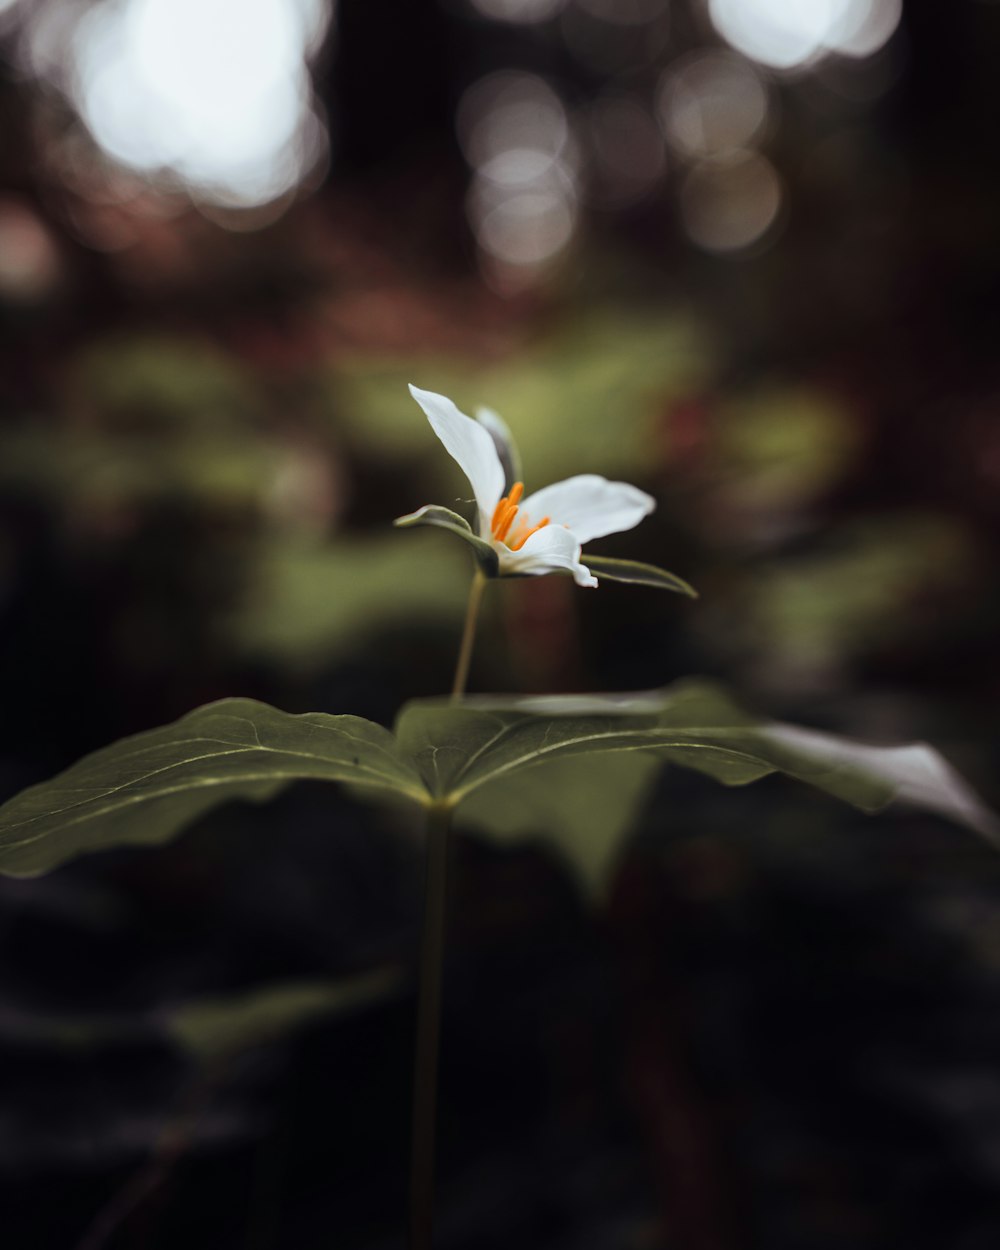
[331,308,708,485]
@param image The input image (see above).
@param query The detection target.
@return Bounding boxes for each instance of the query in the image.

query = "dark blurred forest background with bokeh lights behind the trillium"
[0,0,1000,1250]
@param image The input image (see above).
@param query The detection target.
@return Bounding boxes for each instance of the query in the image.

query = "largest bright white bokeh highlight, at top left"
[70,0,330,208]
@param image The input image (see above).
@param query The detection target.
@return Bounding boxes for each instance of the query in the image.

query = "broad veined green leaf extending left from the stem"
[0,699,426,876]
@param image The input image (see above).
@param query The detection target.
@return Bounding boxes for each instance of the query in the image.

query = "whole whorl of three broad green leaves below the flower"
[0,683,1000,883]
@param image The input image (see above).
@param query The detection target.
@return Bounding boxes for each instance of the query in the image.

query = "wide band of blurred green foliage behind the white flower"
[0,310,978,695]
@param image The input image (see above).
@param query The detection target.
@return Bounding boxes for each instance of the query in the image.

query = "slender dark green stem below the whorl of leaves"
[410,804,451,1250]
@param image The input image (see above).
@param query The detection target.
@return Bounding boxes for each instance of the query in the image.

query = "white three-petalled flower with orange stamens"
[396,386,660,591]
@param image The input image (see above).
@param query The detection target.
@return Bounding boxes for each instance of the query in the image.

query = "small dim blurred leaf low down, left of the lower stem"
[163,969,400,1064]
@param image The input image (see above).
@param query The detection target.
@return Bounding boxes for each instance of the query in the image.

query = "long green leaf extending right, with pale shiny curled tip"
[396,683,1000,843]
